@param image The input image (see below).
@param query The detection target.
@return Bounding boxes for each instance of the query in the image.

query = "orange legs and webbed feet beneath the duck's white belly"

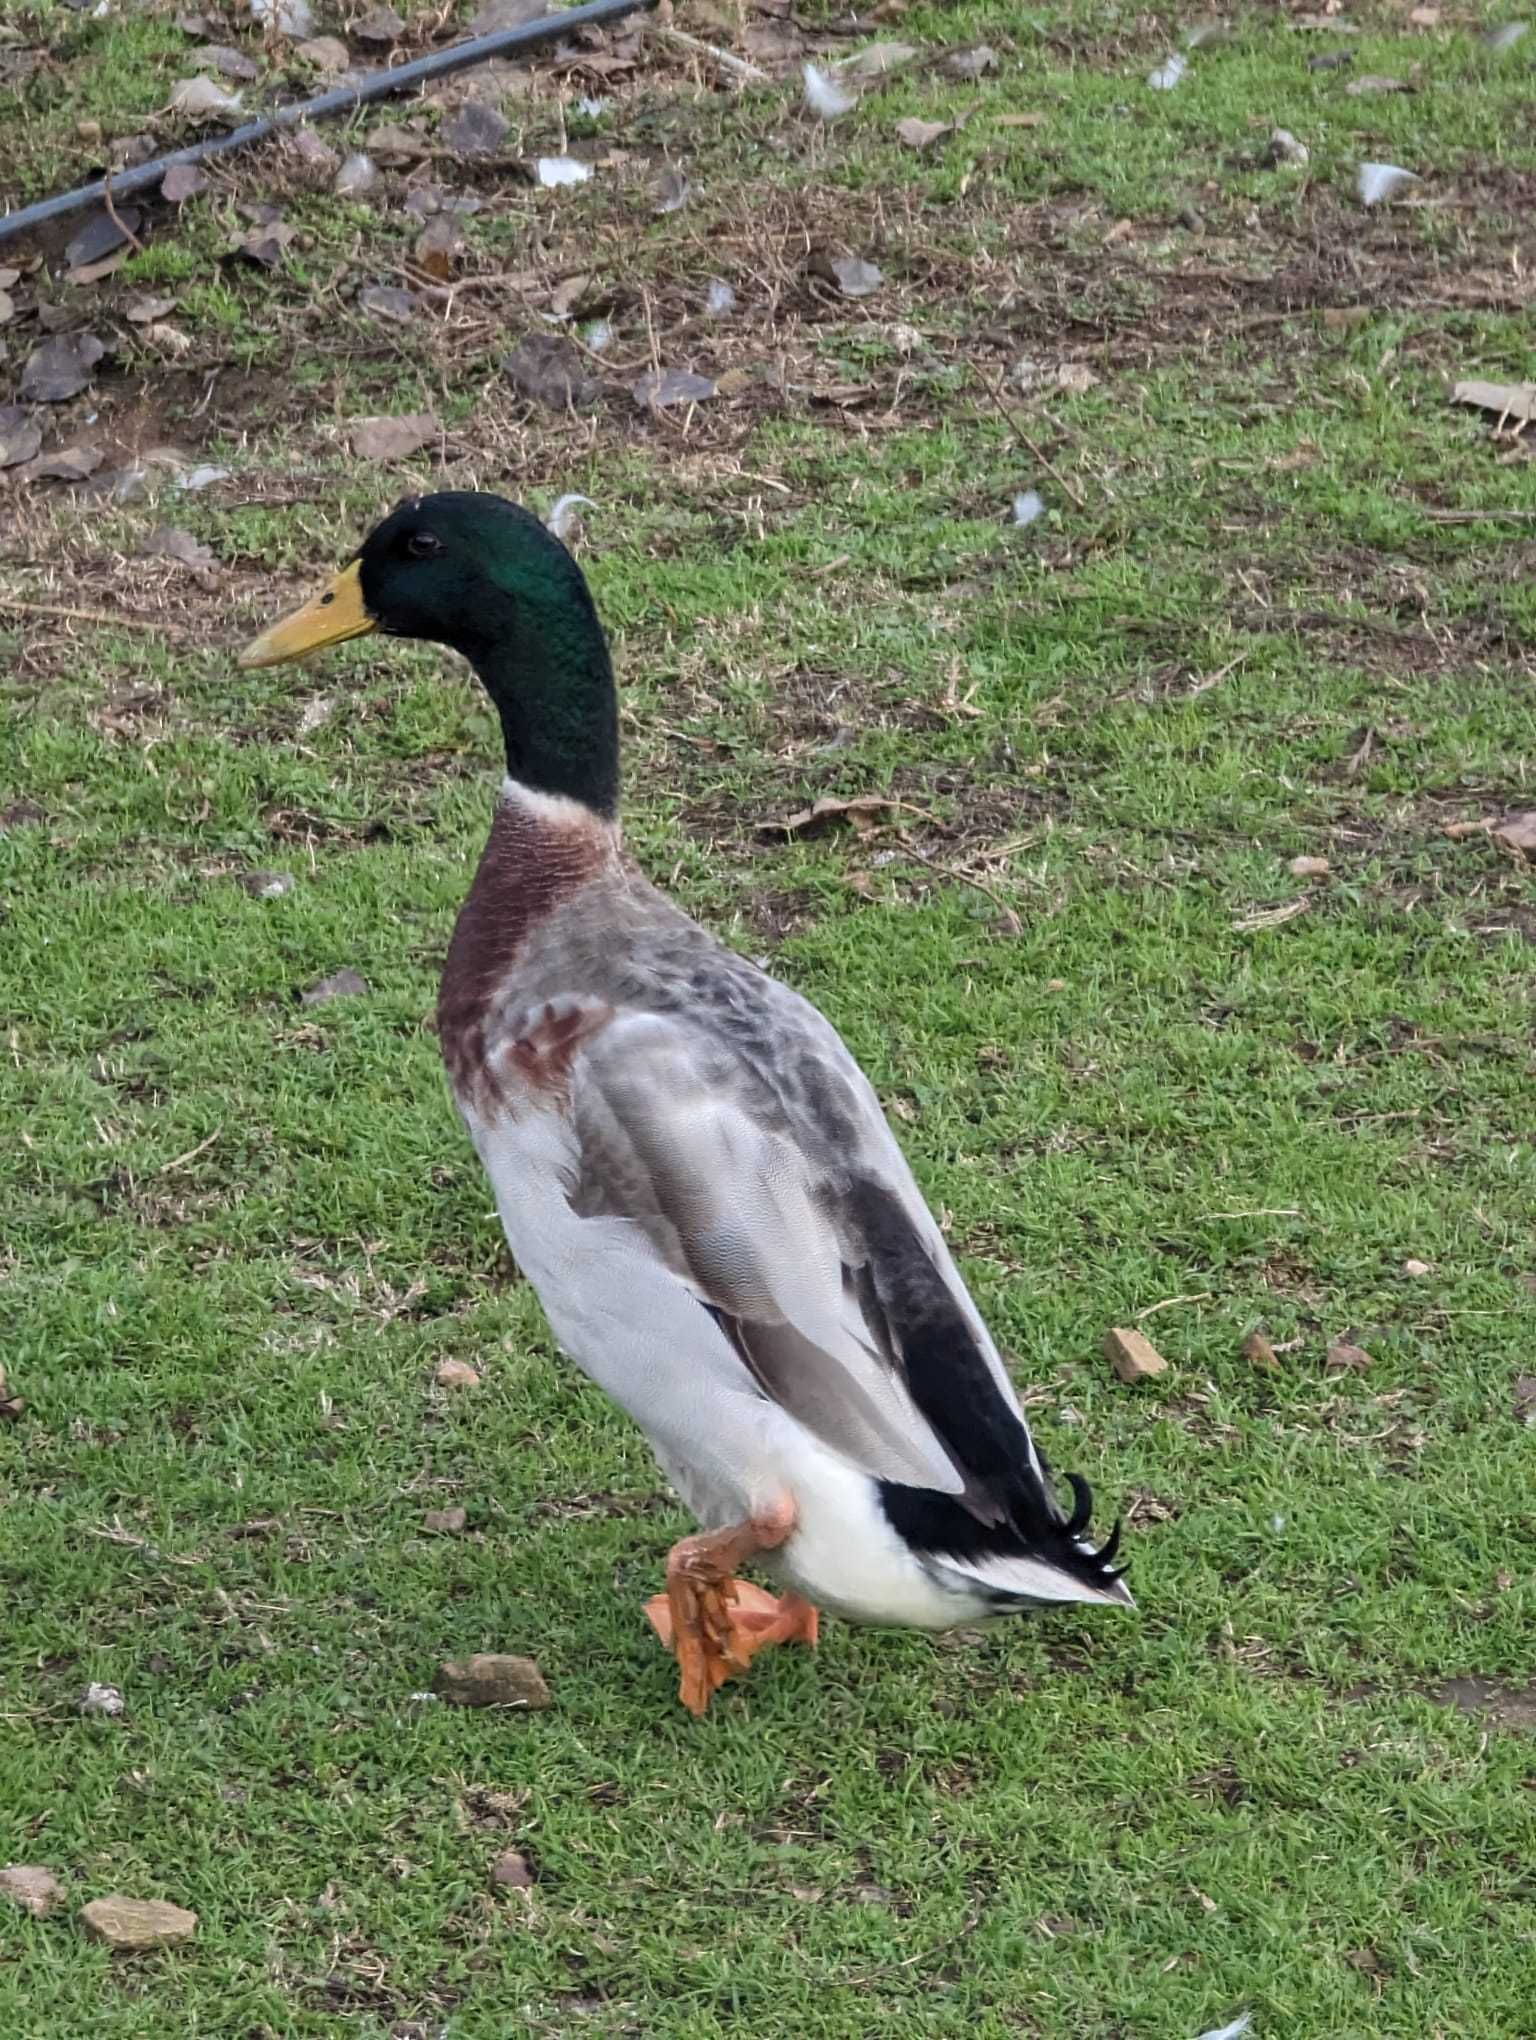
[645,1497,816,1714]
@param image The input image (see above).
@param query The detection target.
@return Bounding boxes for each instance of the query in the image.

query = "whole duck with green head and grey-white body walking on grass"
[241,490,1134,1716]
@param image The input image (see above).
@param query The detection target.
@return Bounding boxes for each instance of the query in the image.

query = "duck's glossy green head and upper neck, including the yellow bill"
[241,490,618,816]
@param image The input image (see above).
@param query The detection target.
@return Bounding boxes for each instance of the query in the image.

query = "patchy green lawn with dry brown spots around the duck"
[0,4,1536,2040]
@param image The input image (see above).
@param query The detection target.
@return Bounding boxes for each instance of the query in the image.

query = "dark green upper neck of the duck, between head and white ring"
[457,579,618,822]
